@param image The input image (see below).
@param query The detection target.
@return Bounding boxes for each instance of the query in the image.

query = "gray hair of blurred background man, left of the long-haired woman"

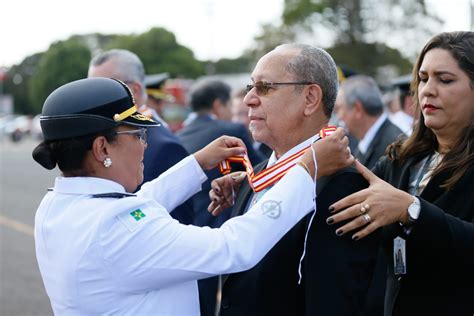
[341,75,384,116]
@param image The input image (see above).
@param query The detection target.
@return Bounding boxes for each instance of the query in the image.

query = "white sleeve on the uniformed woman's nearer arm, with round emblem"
[101,166,315,291]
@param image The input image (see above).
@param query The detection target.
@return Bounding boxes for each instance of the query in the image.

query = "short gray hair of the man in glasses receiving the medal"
[275,43,339,117]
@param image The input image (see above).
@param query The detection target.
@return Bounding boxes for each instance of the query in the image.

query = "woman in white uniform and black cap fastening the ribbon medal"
[33,78,353,315]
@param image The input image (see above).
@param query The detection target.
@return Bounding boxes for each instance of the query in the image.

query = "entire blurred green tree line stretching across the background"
[4,0,441,114]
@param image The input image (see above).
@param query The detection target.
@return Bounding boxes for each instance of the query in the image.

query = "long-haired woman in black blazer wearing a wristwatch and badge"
[328,32,474,316]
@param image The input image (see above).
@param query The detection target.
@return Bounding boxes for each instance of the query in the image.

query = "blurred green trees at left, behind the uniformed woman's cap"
[4,28,204,114]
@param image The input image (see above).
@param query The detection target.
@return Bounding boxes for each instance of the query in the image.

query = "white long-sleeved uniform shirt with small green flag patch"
[35,156,315,315]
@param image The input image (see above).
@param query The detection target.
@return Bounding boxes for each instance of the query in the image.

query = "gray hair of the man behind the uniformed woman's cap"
[89,49,145,87]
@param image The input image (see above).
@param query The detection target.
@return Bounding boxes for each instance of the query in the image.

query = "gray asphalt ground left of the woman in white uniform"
[0,139,59,316]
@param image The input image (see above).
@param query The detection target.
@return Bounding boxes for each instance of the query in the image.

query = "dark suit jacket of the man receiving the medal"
[221,161,378,316]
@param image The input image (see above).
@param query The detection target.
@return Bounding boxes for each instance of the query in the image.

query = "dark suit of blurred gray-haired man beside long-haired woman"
[354,118,404,169]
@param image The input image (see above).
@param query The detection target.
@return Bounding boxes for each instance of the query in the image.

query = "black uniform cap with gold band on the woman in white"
[40,78,159,141]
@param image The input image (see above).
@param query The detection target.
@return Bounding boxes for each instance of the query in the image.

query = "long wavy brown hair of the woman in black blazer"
[387,32,474,190]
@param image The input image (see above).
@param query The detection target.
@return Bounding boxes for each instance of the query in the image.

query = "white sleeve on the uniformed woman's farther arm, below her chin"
[137,155,207,212]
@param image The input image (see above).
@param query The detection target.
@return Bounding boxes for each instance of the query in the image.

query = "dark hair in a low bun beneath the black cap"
[33,129,117,176]
